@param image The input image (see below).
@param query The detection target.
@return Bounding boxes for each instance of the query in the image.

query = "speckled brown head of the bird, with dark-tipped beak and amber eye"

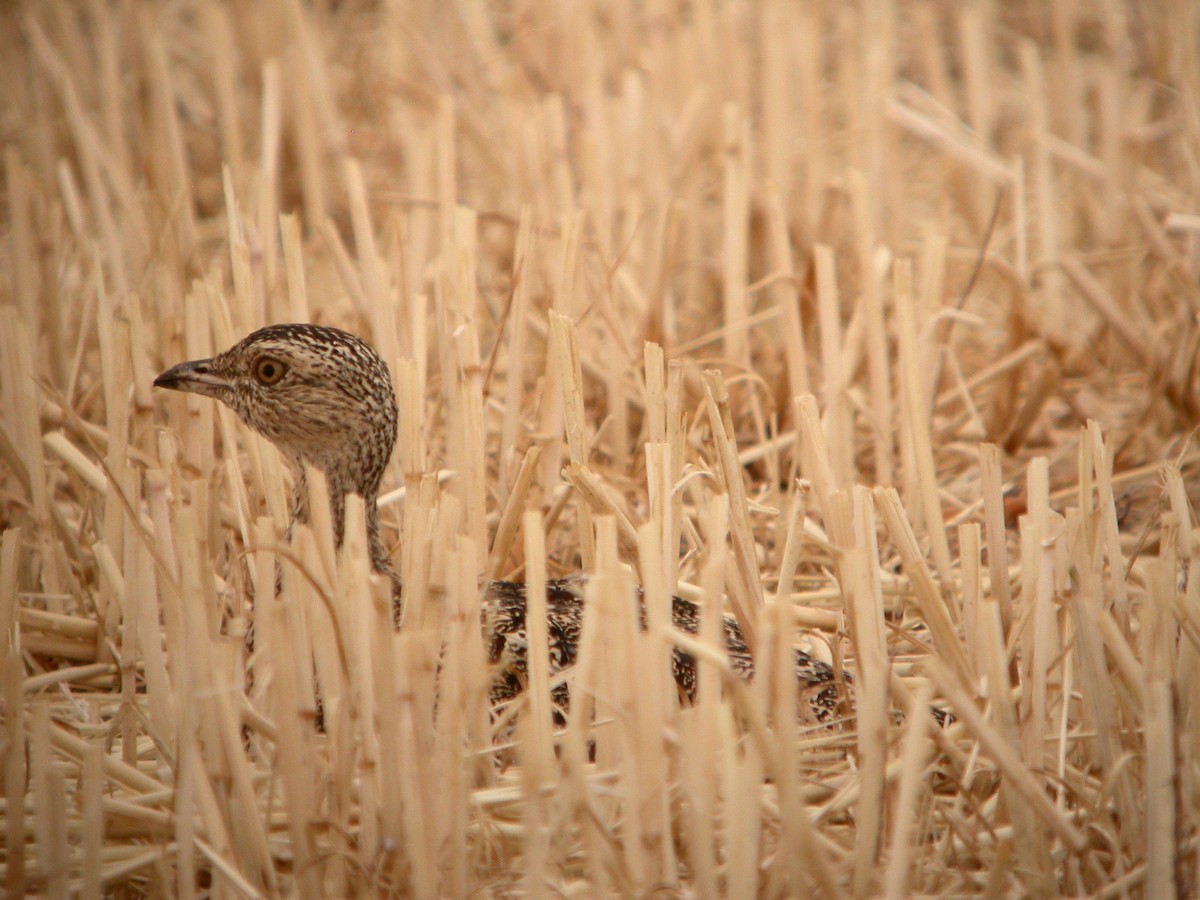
[154,324,397,508]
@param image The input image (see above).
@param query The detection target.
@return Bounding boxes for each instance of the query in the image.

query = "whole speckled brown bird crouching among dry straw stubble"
[154,324,848,721]
